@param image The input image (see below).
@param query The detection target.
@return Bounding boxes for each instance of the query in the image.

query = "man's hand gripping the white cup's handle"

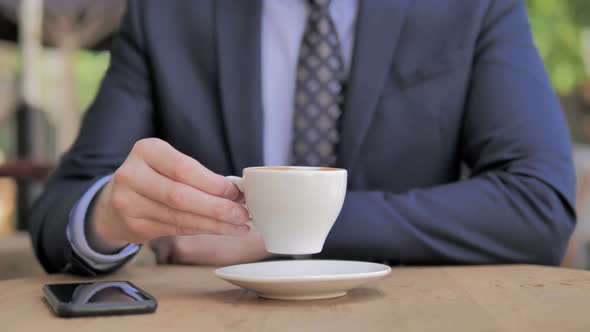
[89,138,250,248]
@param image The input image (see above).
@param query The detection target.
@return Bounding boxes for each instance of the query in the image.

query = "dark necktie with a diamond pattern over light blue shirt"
[292,0,345,166]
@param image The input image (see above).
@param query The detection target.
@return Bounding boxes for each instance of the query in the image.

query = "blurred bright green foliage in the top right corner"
[526,0,590,94]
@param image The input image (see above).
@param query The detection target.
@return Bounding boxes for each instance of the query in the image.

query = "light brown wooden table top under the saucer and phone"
[0,265,590,332]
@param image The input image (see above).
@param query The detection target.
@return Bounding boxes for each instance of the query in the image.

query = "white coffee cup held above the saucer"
[228,166,347,255]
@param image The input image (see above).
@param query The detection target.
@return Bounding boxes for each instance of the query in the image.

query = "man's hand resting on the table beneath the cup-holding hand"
[150,231,270,265]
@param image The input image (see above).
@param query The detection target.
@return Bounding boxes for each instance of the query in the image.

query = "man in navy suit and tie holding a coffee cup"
[31,0,575,274]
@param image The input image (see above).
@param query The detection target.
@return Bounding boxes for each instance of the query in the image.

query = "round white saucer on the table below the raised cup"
[214,260,391,300]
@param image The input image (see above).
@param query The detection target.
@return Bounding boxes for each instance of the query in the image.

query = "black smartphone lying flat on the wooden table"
[43,281,158,317]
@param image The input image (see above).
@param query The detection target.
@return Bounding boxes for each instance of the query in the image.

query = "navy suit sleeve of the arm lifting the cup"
[30,1,154,275]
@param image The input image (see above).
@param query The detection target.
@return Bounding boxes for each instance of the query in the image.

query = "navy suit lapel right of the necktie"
[339,0,413,168]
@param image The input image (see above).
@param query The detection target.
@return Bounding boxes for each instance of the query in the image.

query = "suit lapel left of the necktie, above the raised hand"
[216,0,263,173]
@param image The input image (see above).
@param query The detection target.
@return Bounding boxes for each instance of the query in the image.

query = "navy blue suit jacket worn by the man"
[31,0,575,273]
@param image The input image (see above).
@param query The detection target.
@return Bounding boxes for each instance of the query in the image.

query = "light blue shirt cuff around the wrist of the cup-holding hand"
[66,174,139,270]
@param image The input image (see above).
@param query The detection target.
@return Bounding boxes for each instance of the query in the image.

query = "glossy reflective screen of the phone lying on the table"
[48,281,149,305]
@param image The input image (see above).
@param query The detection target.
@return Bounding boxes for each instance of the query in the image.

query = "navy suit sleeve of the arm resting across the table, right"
[321,1,575,264]
